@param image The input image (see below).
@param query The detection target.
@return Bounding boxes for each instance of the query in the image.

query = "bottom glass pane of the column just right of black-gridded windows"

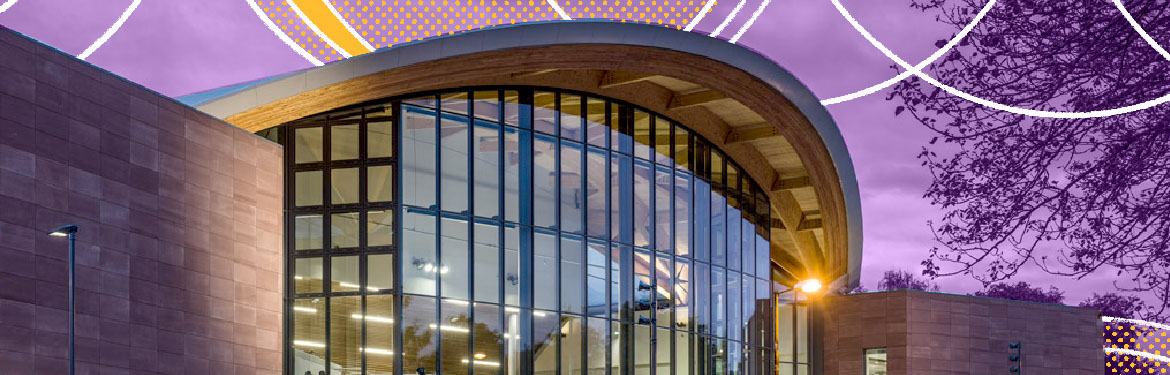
[402,296,439,375]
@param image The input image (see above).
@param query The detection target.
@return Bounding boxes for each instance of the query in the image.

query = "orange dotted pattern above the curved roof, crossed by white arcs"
[256,0,706,62]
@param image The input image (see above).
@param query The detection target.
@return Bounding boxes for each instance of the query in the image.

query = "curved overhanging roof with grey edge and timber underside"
[179,20,862,285]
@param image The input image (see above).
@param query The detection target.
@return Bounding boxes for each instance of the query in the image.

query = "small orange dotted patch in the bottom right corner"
[1104,324,1170,374]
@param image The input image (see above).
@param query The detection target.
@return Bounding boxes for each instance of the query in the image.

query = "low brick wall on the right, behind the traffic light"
[823,291,1104,375]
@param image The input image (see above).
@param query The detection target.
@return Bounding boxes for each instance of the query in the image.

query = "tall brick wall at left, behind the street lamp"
[0,28,282,375]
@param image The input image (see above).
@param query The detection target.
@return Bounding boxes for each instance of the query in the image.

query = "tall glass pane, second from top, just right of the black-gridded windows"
[402,106,438,207]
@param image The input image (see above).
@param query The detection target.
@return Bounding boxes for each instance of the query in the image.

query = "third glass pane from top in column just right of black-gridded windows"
[402,210,439,296]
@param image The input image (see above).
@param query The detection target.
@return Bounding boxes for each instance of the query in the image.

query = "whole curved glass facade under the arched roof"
[263,86,790,375]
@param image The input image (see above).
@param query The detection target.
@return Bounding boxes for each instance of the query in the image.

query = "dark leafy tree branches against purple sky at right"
[887,0,1170,314]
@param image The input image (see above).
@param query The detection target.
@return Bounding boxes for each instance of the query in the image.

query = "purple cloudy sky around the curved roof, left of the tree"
[0,0,1113,304]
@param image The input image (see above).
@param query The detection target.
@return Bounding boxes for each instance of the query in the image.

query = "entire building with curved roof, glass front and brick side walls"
[0,21,1103,375]
